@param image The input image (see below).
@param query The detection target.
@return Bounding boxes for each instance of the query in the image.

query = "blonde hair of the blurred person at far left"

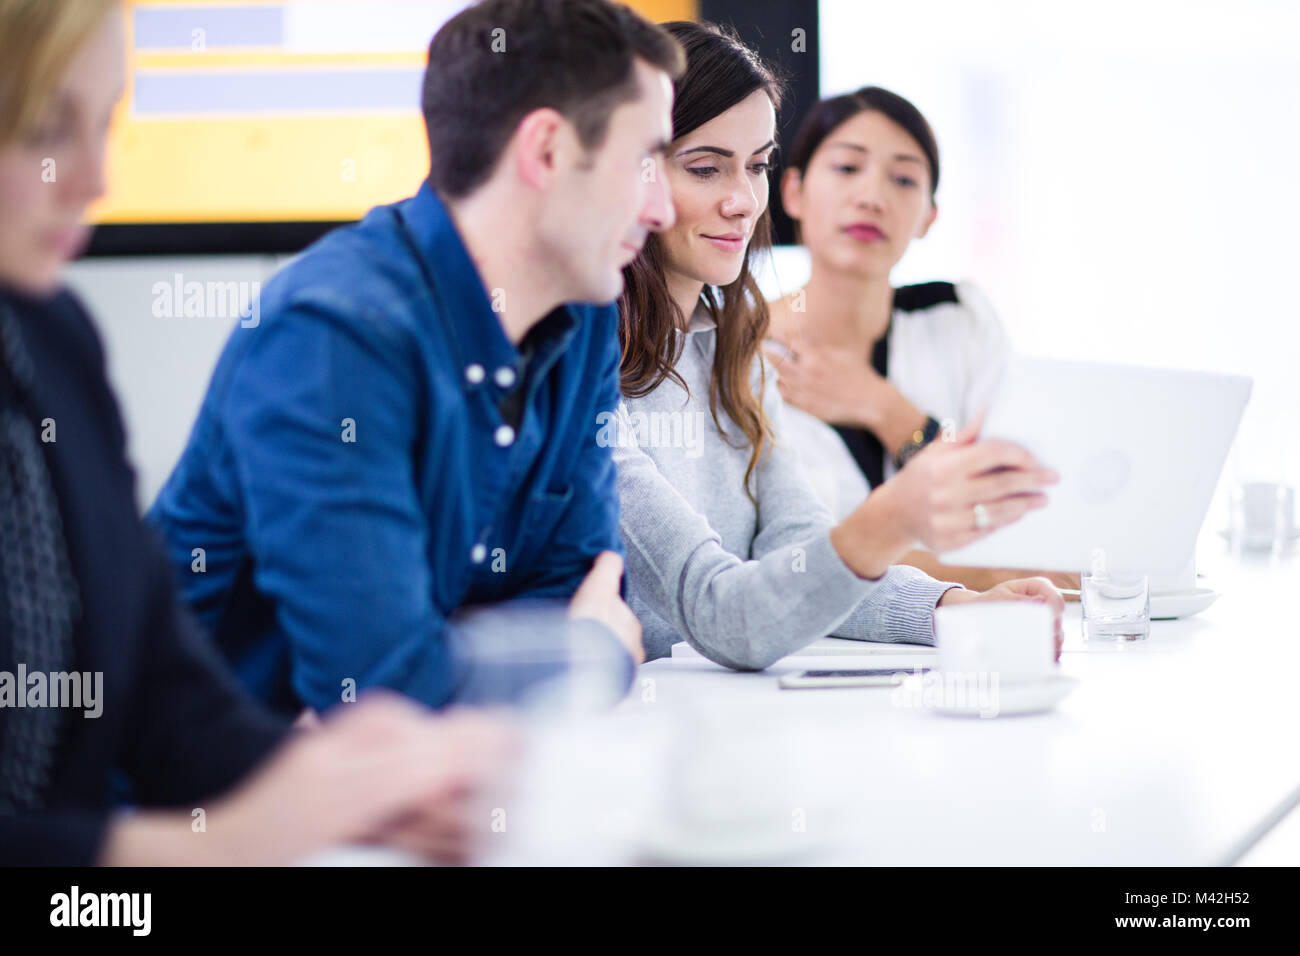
[0,0,121,146]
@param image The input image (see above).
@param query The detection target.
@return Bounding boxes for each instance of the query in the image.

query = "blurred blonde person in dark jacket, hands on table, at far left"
[0,0,507,865]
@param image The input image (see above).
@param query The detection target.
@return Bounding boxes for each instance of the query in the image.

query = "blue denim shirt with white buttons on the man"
[148,183,632,711]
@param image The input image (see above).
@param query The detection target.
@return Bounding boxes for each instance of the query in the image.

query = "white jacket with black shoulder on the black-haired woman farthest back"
[777,281,1011,519]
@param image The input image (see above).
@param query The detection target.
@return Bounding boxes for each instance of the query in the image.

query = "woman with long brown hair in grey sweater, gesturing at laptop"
[613,22,1063,670]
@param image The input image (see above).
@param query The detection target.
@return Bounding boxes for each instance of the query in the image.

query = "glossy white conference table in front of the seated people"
[309,538,1300,866]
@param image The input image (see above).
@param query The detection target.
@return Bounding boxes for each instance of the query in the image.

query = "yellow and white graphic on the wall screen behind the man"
[92,0,696,224]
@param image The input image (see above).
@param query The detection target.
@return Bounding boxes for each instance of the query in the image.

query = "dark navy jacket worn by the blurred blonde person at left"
[0,287,286,866]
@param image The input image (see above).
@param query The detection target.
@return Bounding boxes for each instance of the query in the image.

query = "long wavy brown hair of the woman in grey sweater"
[619,21,783,501]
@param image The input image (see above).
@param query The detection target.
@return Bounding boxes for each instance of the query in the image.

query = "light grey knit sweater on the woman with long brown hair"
[601,312,959,670]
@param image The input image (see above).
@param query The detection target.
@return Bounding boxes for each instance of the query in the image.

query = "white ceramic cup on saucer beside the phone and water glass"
[935,601,1056,684]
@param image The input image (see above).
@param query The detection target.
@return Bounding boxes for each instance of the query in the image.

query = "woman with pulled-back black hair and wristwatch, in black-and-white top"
[768,87,1079,598]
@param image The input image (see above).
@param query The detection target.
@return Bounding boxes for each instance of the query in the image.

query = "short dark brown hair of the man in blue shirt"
[424,0,685,199]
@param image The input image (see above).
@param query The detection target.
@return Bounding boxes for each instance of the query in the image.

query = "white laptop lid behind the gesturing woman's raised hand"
[940,356,1252,574]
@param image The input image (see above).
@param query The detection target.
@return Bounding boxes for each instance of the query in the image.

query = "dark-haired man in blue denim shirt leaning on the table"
[150,0,681,713]
